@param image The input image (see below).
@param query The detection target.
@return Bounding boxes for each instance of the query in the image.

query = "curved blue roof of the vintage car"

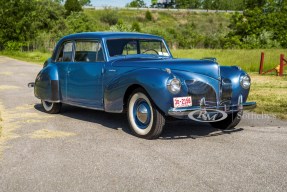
[62,32,162,40]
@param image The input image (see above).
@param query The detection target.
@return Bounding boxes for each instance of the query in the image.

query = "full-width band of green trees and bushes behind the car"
[0,0,287,51]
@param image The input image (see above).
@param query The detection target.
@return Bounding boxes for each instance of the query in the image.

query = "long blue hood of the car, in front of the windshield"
[112,58,220,79]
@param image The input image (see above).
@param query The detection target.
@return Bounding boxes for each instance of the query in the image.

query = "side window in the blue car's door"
[75,41,104,62]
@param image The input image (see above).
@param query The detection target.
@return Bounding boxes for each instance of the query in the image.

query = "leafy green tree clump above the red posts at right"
[226,5,287,48]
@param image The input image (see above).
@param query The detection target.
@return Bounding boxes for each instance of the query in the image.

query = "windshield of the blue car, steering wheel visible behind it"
[107,39,170,57]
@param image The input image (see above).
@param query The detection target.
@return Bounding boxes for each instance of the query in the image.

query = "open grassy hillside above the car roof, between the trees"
[85,9,232,35]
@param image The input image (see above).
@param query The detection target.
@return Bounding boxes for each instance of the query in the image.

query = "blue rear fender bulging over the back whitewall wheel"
[34,63,61,102]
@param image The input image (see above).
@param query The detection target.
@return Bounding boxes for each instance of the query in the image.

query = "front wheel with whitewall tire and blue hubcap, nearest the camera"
[127,89,165,139]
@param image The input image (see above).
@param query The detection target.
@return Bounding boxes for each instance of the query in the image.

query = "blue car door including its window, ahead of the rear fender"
[67,40,105,109]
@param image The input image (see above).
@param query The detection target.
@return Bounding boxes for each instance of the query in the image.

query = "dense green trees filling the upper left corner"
[0,0,91,50]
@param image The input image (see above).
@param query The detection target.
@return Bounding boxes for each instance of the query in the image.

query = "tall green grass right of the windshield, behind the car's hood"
[171,49,287,72]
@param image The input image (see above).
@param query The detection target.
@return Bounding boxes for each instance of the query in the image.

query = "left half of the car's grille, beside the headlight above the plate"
[185,80,217,106]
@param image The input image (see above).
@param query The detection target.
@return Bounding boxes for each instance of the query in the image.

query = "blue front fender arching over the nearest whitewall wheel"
[104,68,179,113]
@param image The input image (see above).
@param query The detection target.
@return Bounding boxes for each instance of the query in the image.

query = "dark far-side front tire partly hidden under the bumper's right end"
[210,111,243,129]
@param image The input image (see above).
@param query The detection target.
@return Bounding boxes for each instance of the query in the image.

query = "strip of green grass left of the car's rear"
[0,51,52,64]
